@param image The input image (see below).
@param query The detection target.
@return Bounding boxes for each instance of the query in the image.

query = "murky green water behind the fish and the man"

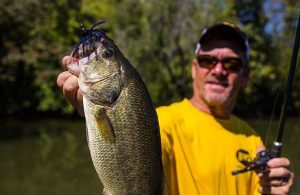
[0,118,300,195]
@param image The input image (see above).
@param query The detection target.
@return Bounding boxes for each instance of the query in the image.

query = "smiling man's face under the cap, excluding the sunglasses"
[192,41,249,107]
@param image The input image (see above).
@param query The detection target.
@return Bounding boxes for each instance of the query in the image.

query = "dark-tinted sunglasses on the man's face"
[197,55,244,72]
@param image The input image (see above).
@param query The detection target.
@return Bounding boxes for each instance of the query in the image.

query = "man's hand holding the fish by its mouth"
[56,56,84,116]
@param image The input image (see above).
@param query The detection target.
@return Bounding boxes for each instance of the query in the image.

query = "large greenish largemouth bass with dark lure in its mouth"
[69,22,164,195]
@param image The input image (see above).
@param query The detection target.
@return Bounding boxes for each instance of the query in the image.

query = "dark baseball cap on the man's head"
[195,22,250,60]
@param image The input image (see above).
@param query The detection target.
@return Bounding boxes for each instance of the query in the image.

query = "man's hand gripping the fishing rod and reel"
[258,157,294,195]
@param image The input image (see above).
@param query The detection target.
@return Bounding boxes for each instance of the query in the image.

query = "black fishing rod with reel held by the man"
[232,13,300,175]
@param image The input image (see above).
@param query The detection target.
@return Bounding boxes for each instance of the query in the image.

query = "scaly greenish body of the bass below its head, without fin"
[84,68,163,194]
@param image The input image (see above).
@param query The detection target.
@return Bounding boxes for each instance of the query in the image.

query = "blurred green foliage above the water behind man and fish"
[0,0,300,115]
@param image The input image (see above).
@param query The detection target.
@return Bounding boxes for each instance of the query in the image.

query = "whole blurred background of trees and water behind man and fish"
[0,0,300,195]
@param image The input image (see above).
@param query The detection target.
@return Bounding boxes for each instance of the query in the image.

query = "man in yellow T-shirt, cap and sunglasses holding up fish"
[57,23,294,195]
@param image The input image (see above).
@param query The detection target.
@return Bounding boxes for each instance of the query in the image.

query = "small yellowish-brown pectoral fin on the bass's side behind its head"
[95,110,116,143]
